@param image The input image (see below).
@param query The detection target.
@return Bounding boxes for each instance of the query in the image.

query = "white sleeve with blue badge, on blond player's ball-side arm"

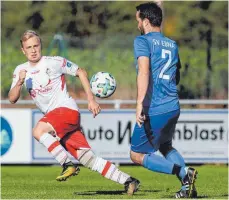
[50,57,79,76]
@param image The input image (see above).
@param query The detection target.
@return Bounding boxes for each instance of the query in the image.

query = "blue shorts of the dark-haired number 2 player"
[131,110,180,153]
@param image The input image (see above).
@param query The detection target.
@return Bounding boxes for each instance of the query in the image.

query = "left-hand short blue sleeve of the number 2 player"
[134,37,150,59]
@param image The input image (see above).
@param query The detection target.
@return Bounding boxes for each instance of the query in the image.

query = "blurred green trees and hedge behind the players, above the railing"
[1,1,228,99]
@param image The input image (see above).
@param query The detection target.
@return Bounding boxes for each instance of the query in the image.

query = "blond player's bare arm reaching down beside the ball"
[76,68,101,117]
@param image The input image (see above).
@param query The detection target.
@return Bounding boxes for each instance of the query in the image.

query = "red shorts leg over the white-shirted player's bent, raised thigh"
[40,107,80,138]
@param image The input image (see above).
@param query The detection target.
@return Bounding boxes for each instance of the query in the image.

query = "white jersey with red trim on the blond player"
[11,56,78,113]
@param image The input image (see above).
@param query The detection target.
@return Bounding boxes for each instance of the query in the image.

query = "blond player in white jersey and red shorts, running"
[9,30,140,195]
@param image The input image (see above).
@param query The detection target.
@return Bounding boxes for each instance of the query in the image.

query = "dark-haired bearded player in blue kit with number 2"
[130,3,197,198]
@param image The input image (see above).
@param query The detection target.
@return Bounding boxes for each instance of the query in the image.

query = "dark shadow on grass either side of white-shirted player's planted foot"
[73,190,162,196]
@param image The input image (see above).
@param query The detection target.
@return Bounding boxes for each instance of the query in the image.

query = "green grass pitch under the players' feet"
[1,165,228,199]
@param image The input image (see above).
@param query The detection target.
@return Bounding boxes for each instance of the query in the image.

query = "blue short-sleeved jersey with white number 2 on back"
[134,32,180,115]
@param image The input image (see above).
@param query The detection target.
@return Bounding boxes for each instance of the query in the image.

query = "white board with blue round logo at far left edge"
[1,109,32,164]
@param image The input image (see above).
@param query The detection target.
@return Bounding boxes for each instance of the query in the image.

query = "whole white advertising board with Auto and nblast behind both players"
[32,109,228,163]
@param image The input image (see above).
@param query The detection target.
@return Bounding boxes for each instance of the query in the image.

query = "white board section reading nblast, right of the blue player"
[173,110,228,163]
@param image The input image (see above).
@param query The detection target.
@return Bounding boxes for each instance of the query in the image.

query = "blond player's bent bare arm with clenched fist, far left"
[8,70,26,104]
